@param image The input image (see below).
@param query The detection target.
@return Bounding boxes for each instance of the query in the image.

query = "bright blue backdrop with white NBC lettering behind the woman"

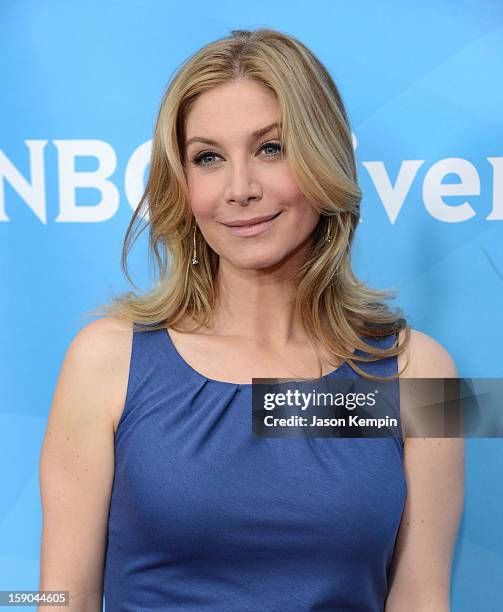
[0,0,503,612]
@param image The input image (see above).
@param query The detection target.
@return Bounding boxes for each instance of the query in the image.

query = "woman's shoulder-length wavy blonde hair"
[86,28,410,380]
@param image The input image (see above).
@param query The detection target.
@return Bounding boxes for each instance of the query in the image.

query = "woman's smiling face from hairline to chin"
[185,80,319,270]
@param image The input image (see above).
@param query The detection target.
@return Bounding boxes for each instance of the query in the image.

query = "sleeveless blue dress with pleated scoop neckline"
[104,329,407,612]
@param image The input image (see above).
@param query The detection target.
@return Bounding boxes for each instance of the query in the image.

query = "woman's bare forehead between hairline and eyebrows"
[185,80,280,139]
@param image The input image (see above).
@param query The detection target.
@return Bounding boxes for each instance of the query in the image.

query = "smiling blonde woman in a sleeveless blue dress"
[40,29,463,612]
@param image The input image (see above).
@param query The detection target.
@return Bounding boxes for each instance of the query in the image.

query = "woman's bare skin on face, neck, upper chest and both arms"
[39,82,464,612]
